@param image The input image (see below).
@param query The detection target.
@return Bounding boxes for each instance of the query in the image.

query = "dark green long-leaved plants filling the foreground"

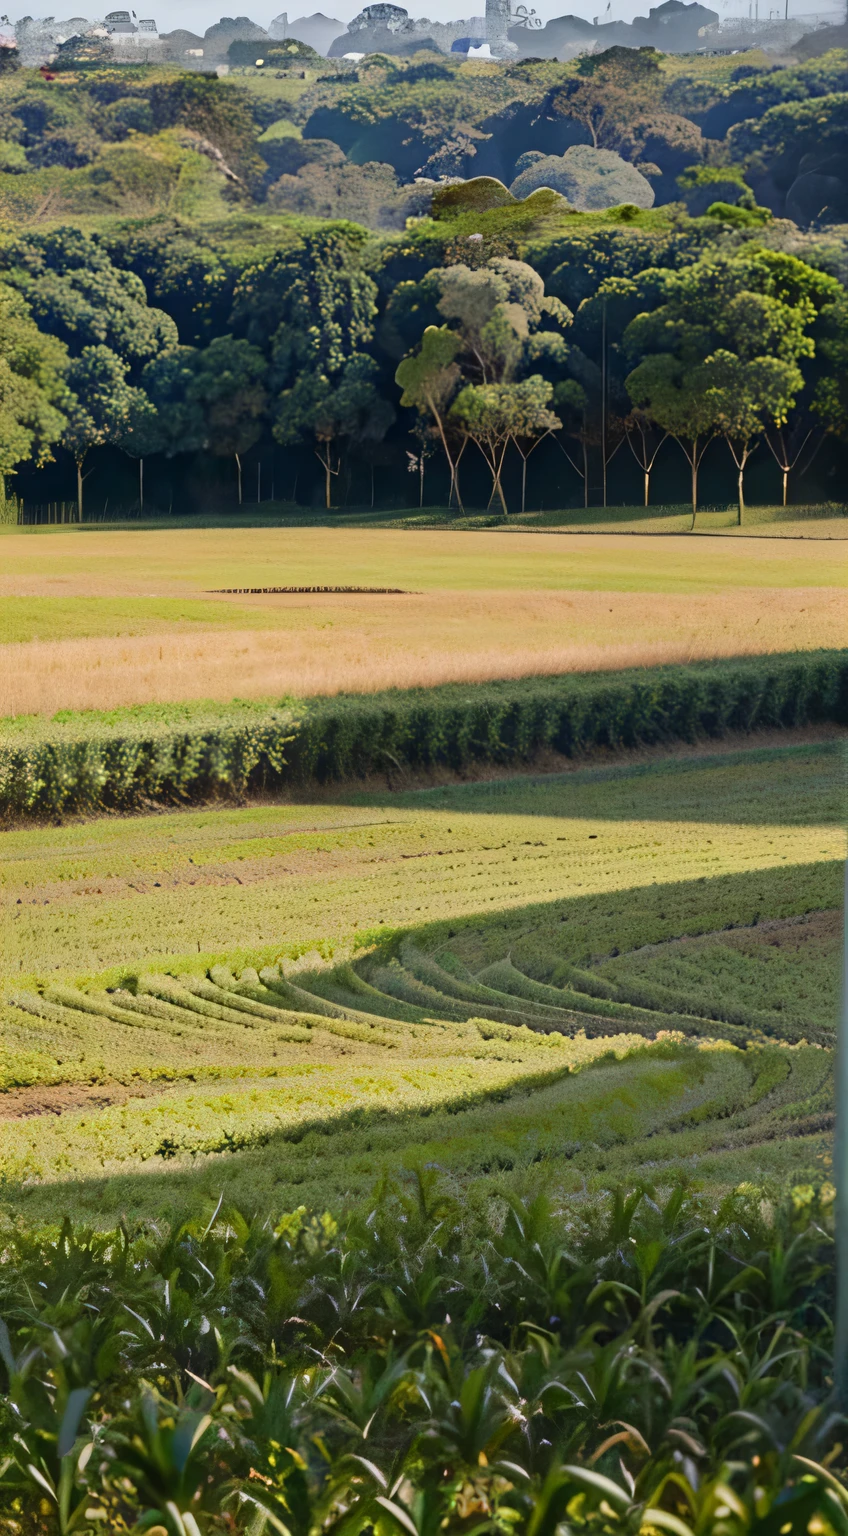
[0,1169,848,1536]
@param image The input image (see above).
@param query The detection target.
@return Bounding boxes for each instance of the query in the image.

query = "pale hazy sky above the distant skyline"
[11,0,843,35]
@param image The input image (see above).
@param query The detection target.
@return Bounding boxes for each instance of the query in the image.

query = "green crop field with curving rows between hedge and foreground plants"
[0,742,845,1224]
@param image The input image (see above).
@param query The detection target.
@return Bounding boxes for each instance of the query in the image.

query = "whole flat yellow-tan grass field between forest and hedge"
[0,528,848,714]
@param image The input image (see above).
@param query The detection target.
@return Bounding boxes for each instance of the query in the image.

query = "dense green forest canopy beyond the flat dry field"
[0,49,848,516]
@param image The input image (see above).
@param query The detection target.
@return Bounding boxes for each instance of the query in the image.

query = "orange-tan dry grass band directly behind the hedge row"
[0,587,846,714]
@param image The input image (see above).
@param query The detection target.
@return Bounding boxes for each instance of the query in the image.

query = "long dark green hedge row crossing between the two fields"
[0,651,848,816]
